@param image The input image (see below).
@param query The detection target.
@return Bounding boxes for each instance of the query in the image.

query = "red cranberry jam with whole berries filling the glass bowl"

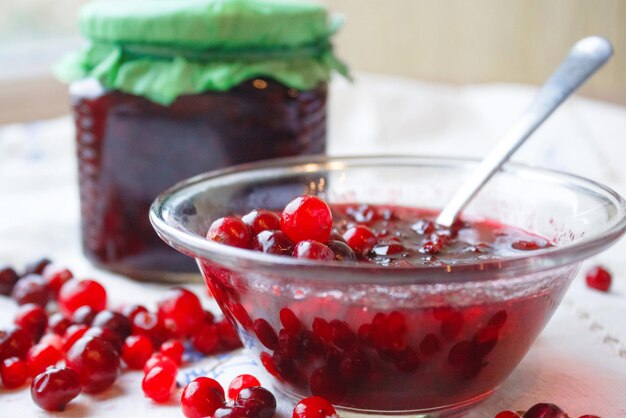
[200,199,564,413]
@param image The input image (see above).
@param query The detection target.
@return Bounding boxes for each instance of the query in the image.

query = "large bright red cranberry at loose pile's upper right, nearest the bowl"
[158,287,204,337]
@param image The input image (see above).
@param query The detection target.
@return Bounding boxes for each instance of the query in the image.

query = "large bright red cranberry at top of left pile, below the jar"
[59,279,107,318]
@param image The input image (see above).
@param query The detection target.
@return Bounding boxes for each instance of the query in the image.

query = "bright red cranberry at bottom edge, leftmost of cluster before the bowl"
[180,377,224,418]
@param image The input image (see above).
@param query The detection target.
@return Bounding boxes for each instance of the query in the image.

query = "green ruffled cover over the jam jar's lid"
[55,0,347,104]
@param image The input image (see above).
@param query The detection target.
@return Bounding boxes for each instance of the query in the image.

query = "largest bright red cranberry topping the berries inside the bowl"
[280,195,333,243]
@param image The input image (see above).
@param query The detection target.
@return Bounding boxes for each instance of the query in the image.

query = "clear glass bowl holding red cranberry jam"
[150,156,626,417]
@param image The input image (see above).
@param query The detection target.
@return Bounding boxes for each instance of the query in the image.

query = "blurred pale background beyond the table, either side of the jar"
[0,0,626,124]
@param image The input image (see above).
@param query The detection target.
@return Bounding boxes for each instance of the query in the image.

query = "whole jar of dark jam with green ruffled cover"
[57,0,346,280]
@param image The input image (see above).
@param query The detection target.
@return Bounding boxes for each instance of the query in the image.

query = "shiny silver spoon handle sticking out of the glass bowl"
[437,36,613,227]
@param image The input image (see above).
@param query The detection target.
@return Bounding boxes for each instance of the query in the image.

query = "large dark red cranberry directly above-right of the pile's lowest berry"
[66,337,120,393]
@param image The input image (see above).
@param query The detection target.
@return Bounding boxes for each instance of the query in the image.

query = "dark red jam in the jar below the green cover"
[71,79,327,279]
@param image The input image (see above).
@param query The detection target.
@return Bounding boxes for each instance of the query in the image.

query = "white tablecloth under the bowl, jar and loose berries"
[0,74,626,418]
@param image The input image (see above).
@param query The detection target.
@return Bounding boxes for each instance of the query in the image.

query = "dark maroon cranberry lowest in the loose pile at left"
[30,368,81,411]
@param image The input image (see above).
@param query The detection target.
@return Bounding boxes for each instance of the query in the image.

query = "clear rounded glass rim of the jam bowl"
[149,154,626,284]
